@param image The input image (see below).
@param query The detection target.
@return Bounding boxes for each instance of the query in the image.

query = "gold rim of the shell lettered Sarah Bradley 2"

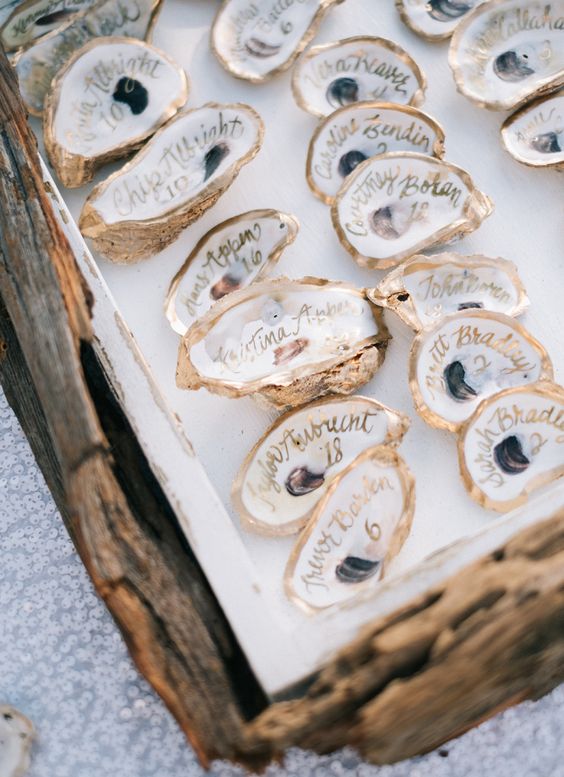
[456,380,564,513]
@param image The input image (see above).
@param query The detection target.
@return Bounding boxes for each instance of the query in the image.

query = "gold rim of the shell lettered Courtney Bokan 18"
[331,151,495,270]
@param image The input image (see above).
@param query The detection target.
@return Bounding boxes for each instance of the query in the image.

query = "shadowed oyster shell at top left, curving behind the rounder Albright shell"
[14,0,162,116]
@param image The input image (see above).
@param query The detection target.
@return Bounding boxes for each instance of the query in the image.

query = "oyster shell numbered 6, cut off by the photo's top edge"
[211,0,343,83]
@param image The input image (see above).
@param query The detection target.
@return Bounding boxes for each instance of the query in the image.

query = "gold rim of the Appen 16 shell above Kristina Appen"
[164,208,300,337]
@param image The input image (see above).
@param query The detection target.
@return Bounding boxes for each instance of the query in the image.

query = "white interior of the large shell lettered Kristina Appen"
[189,283,379,386]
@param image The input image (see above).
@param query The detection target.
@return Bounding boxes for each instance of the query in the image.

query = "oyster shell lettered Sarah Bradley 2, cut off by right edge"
[458,382,564,512]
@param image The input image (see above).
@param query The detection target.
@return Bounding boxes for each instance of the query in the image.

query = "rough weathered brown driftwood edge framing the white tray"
[0,42,564,768]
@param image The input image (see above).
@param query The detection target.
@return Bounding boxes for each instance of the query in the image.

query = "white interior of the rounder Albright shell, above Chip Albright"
[52,38,187,158]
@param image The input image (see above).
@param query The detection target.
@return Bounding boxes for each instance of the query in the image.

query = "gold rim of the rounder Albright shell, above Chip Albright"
[42,35,191,188]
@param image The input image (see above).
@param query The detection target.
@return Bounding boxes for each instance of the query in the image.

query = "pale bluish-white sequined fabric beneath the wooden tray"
[0,390,564,777]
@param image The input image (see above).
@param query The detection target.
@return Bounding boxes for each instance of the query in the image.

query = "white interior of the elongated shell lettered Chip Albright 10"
[89,105,262,224]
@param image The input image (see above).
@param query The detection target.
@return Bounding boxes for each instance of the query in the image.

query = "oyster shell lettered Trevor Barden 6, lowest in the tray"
[284,446,415,612]
